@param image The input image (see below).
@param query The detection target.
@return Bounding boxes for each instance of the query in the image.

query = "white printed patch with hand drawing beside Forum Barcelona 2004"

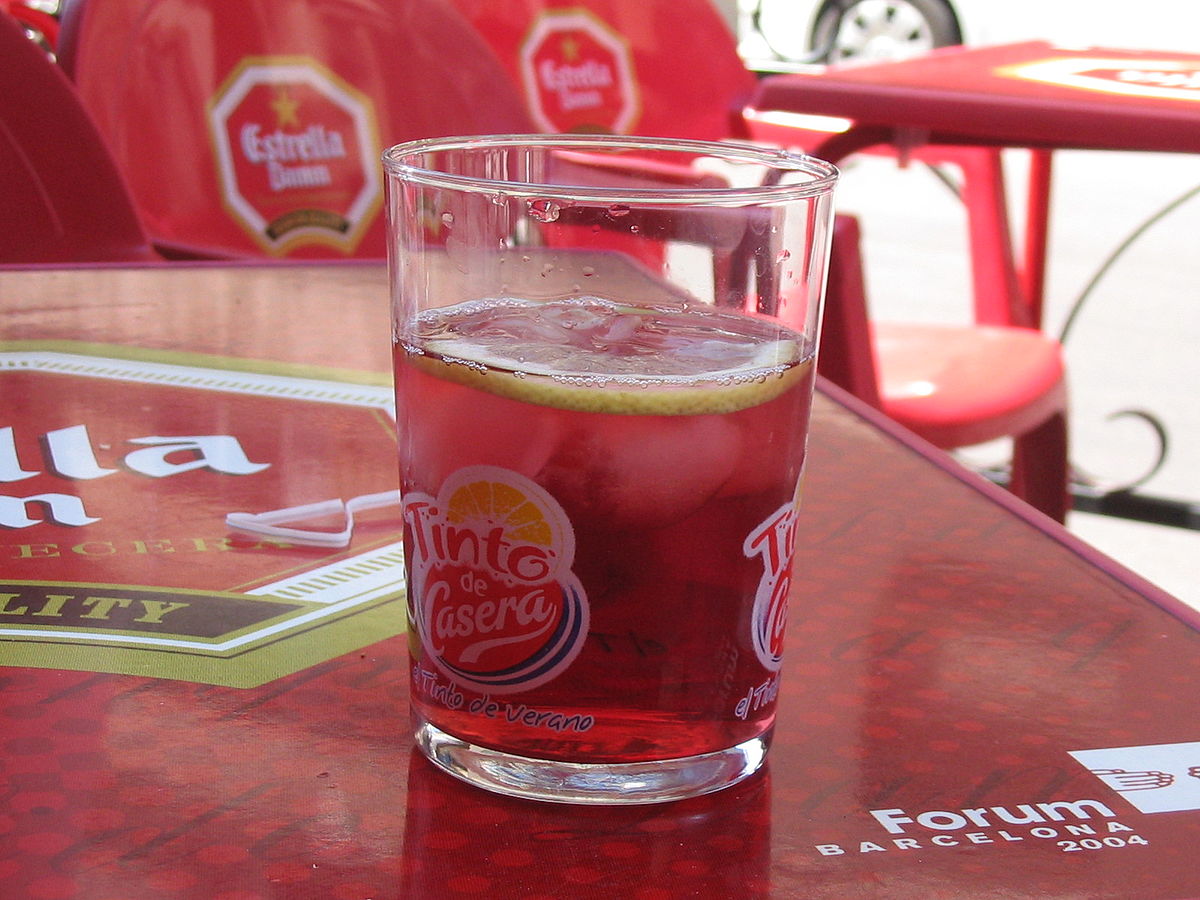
[1070,740,1200,812]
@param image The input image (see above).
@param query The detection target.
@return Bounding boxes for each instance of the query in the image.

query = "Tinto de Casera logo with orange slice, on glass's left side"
[404,466,588,694]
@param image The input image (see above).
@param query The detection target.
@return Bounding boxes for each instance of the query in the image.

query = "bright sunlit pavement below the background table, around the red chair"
[838,151,1200,608]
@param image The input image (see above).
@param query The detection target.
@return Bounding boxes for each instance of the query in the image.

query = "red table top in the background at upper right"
[750,41,1200,152]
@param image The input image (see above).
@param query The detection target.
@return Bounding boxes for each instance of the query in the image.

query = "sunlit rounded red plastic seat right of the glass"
[874,323,1067,449]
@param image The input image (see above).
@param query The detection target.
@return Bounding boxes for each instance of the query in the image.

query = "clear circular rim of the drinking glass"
[382,133,839,205]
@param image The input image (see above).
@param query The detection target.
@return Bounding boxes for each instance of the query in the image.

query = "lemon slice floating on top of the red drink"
[403,298,811,415]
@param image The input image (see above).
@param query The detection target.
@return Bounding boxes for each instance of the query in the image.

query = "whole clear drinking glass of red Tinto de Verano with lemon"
[384,136,836,804]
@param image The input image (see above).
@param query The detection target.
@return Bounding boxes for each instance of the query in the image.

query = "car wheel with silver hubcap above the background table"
[812,0,962,62]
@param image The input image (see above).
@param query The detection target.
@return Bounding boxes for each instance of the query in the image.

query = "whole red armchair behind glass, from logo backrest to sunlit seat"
[452,0,1067,520]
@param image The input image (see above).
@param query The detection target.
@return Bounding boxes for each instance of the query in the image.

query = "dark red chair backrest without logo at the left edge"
[0,13,155,263]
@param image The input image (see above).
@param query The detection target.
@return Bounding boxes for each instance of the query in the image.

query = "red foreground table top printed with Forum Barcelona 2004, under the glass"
[0,265,1200,900]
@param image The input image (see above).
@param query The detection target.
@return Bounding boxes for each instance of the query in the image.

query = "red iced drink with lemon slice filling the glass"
[396,298,814,762]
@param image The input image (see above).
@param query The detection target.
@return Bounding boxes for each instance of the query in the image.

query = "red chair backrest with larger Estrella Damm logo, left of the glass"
[60,0,533,258]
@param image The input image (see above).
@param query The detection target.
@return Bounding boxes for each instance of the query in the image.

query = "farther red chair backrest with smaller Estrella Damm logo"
[451,0,755,140]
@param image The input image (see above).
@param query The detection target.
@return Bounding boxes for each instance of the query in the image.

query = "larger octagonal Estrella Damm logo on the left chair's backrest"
[209,58,383,254]
